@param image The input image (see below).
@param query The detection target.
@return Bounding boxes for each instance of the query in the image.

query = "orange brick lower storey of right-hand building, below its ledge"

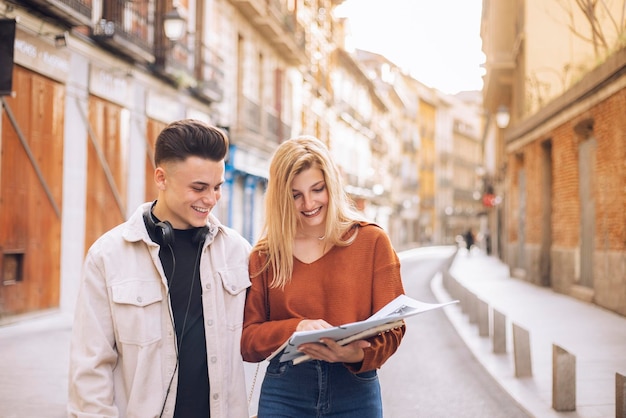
[506,50,626,315]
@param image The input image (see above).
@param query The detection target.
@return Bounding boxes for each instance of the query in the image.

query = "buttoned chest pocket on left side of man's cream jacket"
[111,280,163,345]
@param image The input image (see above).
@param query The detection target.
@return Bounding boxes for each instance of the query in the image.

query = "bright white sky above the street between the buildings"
[336,0,485,94]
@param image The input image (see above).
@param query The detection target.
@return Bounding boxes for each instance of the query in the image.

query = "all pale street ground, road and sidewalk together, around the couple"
[0,249,626,418]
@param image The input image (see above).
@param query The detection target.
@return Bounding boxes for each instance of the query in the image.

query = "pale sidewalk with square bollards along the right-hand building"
[432,249,626,418]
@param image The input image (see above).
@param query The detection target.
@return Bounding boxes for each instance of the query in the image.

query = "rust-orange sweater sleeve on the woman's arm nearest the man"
[241,252,303,362]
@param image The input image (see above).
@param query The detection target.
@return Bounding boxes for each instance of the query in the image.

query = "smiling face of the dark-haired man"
[154,156,224,229]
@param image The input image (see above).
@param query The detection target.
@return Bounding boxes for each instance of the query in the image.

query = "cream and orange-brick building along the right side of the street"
[482,0,626,315]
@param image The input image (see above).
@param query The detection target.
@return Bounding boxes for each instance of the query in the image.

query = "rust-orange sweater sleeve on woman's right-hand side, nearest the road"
[346,228,406,373]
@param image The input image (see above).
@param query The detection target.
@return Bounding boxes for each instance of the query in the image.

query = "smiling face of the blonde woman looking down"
[291,168,328,234]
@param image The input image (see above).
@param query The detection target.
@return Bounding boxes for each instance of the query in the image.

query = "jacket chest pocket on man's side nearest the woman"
[217,266,252,329]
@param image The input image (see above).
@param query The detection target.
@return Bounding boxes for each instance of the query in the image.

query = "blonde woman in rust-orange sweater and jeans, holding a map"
[242,136,405,418]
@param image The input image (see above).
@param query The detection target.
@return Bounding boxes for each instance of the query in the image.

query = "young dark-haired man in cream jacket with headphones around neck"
[68,120,250,418]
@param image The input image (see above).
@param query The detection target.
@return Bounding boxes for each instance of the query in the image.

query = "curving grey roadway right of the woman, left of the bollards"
[379,247,529,418]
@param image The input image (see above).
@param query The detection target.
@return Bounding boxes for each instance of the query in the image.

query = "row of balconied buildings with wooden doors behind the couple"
[0,0,482,323]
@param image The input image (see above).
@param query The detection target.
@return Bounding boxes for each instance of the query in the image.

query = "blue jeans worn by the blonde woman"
[258,359,383,418]
